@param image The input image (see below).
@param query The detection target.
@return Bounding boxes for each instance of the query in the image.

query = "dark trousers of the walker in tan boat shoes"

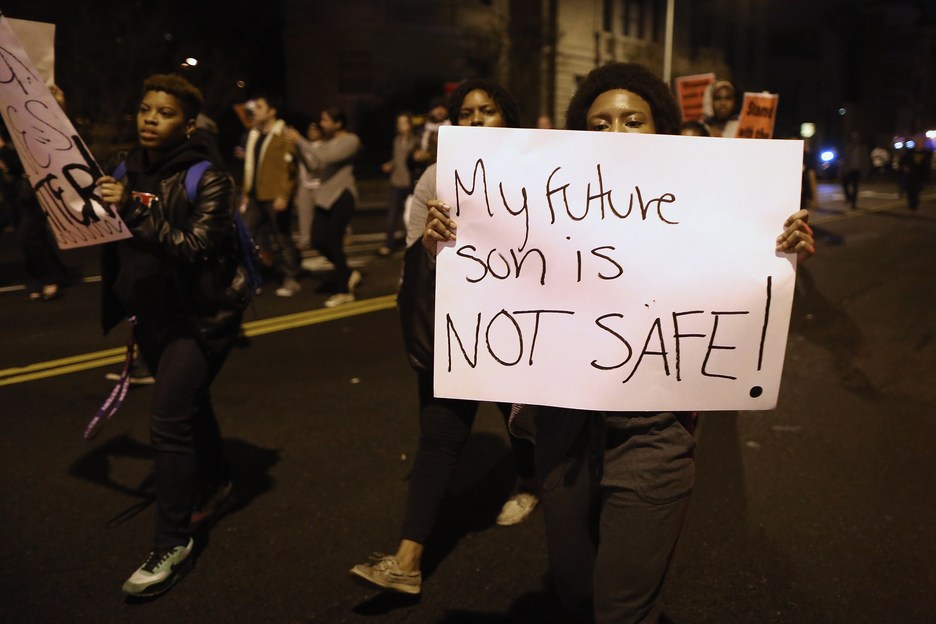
[403,372,534,544]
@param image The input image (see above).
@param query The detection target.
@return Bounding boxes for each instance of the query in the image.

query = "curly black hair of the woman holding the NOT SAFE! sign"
[566,63,681,134]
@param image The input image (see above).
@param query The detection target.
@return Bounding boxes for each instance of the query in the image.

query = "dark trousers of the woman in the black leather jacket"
[134,321,233,548]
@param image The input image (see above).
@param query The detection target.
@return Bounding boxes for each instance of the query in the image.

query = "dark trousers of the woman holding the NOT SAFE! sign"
[536,408,695,624]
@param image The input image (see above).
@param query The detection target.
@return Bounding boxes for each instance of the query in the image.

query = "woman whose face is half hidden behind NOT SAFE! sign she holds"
[423,63,814,624]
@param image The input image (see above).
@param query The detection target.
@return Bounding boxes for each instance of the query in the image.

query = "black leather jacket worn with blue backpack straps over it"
[101,163,251,341]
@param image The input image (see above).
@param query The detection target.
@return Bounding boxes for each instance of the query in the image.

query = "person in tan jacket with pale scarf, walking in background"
[244,96,301,297]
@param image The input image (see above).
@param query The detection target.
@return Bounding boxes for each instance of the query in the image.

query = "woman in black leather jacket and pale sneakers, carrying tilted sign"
[98,75,249,596]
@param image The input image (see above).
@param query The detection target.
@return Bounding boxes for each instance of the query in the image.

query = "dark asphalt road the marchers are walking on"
[0,178,936,624]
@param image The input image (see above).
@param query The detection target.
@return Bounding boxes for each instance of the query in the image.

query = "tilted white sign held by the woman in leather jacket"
[0,15,131,249]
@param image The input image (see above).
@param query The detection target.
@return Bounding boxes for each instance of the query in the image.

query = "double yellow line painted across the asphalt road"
[0,295,396,386]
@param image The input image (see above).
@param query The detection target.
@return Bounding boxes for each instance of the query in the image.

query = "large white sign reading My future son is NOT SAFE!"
[434,127,803,410]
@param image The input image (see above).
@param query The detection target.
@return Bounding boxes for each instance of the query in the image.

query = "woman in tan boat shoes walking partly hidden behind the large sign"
[351,80,539,594]
